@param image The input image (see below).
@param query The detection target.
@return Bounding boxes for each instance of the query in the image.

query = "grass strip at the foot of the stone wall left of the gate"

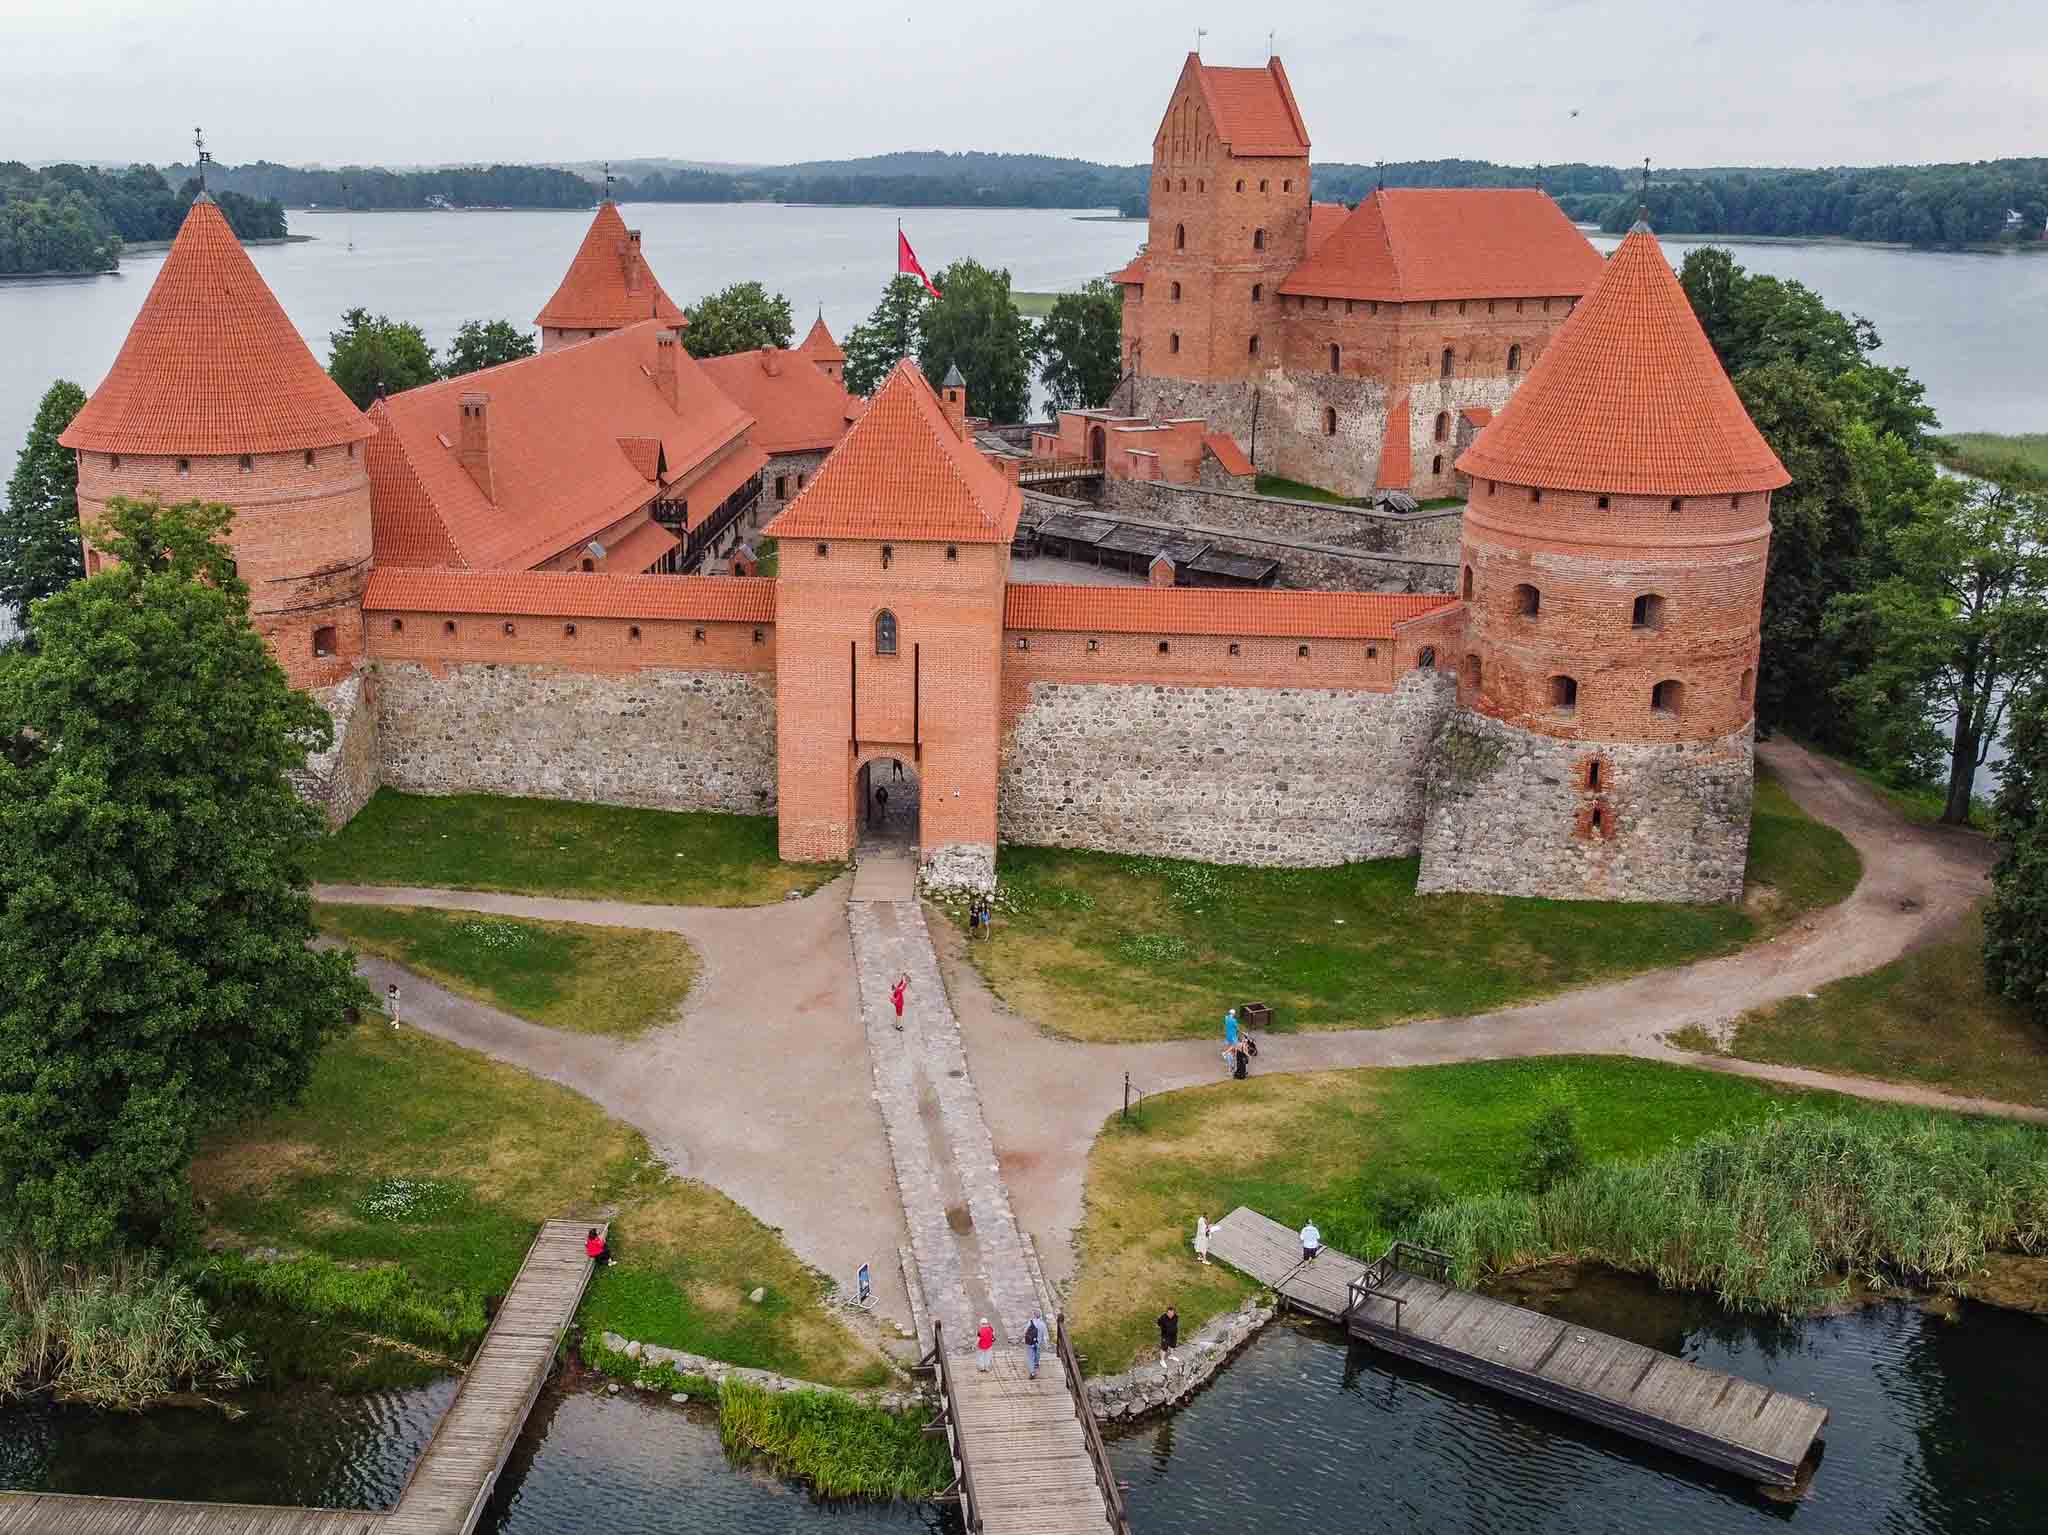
[307,788,840,907]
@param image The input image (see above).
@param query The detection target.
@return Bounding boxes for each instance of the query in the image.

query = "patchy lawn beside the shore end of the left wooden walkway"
[193,1019,889,1386]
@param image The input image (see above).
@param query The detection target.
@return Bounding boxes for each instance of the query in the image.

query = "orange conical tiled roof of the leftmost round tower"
[59,196,377,454]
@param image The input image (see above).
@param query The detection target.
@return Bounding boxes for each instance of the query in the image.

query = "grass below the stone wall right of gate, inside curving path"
[971,770,1862,1040]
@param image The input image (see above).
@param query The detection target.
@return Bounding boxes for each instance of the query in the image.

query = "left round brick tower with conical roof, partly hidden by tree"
[61,194,375,688]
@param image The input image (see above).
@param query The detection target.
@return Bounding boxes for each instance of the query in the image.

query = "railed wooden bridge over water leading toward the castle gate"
[920,1316,1130,1535]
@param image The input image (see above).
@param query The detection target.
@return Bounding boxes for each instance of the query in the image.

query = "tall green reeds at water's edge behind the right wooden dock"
[1403,1113,2048,1314]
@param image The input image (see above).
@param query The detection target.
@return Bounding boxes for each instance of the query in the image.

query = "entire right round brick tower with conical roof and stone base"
[1421,223,1790,901]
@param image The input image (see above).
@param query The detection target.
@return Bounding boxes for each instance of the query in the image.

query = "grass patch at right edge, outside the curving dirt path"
[1673,913,2048,1107]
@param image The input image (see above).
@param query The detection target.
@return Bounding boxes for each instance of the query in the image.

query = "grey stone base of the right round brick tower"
[1417,710,1755,901]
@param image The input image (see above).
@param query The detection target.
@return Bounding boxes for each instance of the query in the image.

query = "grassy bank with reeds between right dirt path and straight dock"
[1071,1056,2048,1371]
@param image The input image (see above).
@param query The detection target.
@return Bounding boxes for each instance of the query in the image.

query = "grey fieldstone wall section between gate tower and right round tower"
[997,671,1456,866]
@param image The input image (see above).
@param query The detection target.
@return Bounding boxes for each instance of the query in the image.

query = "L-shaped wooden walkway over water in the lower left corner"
[0,1220,606,1535]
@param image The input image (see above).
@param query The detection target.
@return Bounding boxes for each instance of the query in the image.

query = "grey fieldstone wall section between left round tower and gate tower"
[375,661,776,815]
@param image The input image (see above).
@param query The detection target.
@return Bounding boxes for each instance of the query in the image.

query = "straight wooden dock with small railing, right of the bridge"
[1208,1208,1827,1488]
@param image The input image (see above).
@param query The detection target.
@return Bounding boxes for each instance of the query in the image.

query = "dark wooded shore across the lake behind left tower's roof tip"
[0,160,285,276]
